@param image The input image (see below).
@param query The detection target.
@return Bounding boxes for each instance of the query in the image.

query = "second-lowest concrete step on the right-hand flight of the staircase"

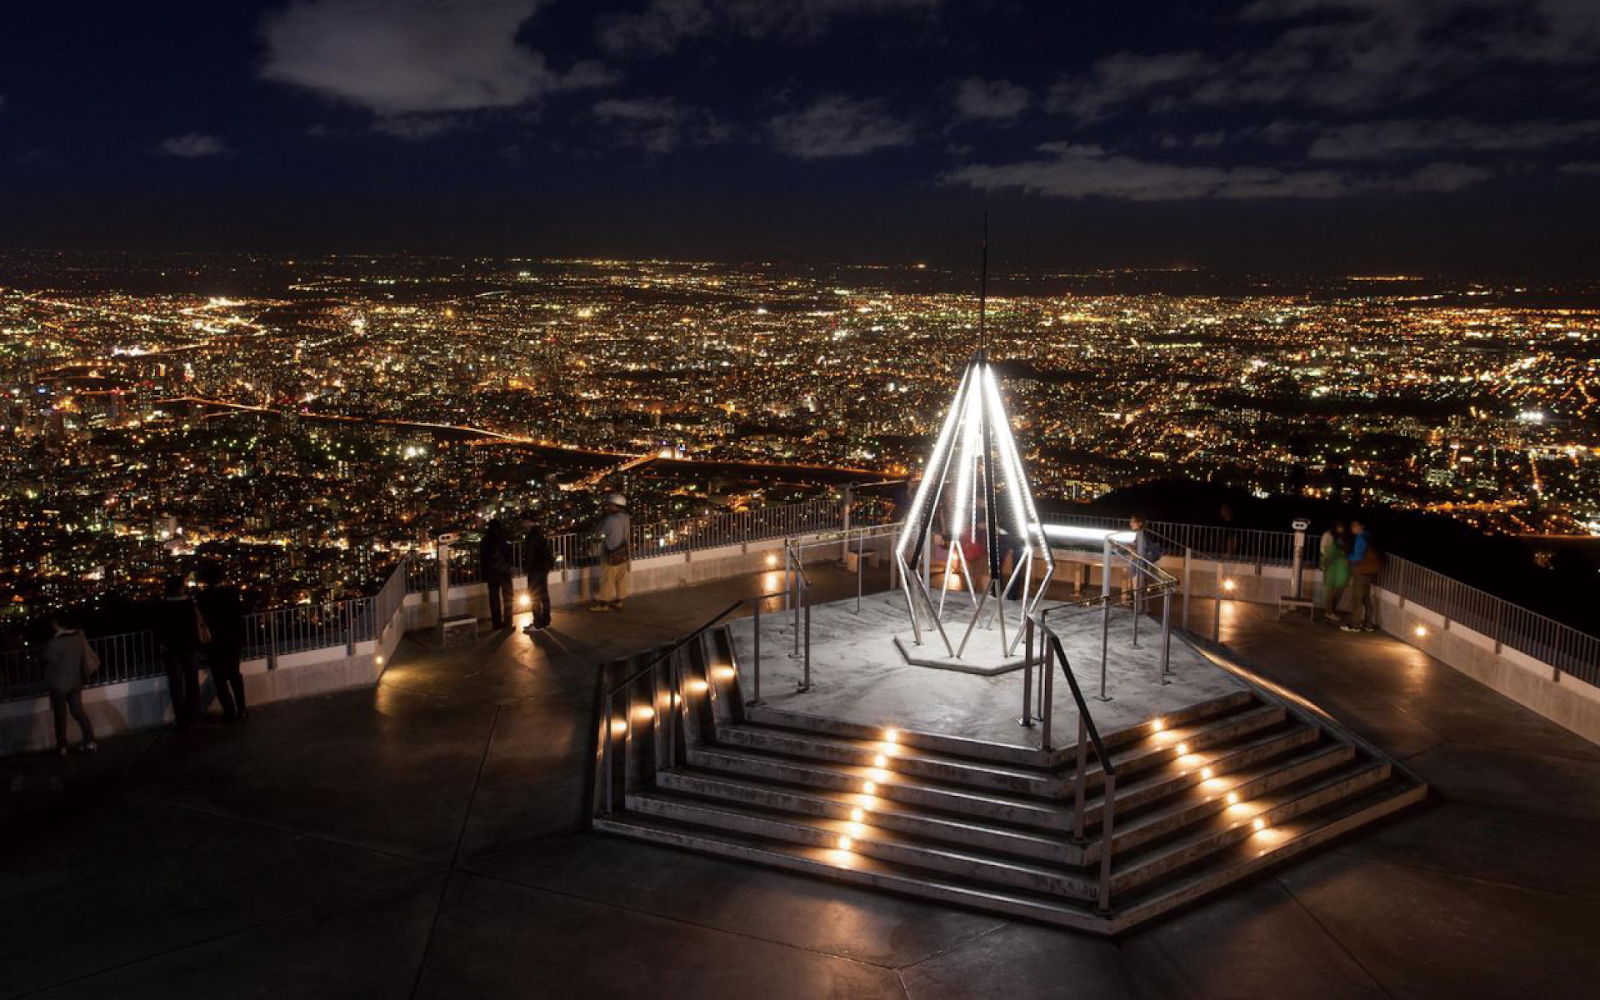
[1112,757,1390,894]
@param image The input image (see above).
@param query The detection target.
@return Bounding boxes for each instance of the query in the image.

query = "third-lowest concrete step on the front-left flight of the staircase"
[656,768,1082,864]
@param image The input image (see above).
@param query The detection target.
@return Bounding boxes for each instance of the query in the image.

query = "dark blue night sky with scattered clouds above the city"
[0,0,1600,277]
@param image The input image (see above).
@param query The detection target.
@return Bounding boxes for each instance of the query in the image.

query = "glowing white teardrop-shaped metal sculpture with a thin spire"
[894,225,1056,659]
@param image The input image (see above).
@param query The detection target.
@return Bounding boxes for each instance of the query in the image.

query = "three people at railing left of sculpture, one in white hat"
[478,493,632,635]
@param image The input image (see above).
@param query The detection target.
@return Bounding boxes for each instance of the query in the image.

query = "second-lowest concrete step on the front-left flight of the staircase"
[627,790,1096,899]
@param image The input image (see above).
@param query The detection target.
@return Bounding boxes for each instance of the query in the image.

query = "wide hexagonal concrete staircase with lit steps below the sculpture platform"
[592,630,1427,934]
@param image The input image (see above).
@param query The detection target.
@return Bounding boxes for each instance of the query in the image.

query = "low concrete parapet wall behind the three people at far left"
[0,640,384,754]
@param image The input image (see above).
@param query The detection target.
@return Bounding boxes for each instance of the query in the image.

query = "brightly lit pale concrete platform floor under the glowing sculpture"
[733,592,1245,747]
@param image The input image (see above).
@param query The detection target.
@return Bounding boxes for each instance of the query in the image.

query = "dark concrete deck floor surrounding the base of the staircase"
[0,573,1600,1000]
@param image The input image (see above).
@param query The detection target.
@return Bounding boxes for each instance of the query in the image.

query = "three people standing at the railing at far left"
[40,563,250,757]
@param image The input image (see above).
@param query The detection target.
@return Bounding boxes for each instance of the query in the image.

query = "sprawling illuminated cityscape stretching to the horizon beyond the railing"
[0,256,1600,614]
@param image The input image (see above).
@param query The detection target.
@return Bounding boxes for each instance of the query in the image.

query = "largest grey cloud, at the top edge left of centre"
[261,0,610,116]
